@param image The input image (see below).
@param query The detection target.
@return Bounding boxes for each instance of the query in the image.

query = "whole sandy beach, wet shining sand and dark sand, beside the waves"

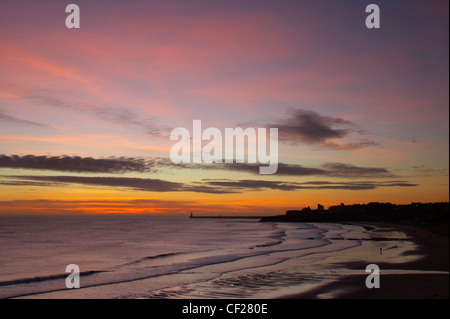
[6,222,449,299]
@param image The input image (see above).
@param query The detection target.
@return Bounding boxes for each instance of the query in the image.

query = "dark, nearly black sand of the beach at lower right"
[278,222,449,299]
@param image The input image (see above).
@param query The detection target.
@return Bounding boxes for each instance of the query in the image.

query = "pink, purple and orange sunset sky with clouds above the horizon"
[0,0,449,215]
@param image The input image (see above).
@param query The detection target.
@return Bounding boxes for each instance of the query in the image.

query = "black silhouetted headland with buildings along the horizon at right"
[261,202,449,224]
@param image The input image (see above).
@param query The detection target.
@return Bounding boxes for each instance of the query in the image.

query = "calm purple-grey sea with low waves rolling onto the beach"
[0,215,414,299]
